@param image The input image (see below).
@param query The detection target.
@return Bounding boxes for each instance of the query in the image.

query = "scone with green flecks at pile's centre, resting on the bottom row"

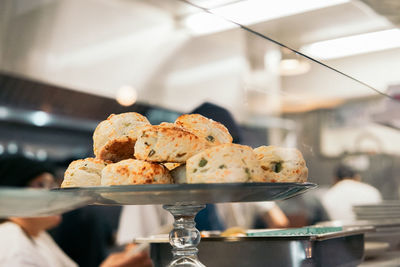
[135,123,208,163]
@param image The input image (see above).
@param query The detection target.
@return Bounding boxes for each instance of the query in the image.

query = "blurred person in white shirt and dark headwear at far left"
[0,155,152,267]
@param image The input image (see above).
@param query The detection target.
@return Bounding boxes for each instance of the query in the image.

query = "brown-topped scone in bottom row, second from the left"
[101,159,172,185]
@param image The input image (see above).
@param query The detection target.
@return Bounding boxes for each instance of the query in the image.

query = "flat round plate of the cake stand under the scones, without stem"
[57,183,316,205]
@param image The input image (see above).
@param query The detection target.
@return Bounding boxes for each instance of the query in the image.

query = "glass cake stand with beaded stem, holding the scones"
[57,183,316,267]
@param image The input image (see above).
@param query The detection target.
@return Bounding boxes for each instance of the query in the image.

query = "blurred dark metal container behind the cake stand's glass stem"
[144,227,373,267]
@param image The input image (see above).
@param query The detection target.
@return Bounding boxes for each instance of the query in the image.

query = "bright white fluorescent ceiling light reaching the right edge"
[300,29,400,60]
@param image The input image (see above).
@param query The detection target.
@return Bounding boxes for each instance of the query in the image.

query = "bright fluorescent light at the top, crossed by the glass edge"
[183,0,350,35]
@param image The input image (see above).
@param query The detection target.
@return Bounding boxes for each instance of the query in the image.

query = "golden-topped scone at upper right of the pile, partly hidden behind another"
[175,114,232,146]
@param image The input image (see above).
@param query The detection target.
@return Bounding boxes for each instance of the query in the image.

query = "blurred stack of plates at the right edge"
[353,201,400,220]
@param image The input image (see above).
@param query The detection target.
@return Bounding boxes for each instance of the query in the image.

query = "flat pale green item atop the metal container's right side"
[247,227,343,236]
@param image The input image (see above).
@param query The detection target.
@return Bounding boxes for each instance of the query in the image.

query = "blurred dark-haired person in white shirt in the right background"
[322,164,382,221]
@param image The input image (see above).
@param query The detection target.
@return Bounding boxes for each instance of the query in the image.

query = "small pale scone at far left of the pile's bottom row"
[61,158,107,187]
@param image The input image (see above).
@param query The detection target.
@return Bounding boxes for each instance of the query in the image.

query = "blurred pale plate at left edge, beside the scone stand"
[0,187,94,218]
